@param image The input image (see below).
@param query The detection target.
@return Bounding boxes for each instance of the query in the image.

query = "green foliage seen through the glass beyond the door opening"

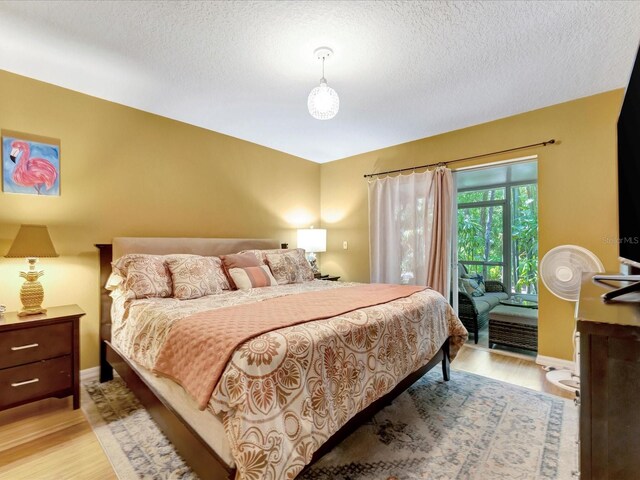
[457,184,538,294]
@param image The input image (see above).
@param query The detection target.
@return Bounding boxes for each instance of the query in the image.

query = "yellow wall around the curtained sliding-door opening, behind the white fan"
[320,90,622,359]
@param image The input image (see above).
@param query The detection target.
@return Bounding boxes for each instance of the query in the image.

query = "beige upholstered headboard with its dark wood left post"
[96,237,279,381]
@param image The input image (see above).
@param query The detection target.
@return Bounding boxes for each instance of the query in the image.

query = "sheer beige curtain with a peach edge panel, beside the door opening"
[369,167,453,298]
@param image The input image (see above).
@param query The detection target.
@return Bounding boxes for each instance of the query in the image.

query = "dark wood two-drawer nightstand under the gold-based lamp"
[0,305,84,410]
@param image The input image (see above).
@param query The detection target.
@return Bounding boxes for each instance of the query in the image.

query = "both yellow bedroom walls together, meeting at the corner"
[0,65,622,368]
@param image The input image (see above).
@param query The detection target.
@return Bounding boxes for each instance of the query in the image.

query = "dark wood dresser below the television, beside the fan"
[577,275,640,480]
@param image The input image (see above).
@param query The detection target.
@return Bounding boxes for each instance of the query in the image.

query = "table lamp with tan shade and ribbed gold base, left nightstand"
[5,225,58,317]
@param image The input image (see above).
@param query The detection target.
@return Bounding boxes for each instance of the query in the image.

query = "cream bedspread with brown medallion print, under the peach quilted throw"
[112,280,467,480]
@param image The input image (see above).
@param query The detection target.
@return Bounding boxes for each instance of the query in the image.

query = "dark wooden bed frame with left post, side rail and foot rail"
[96,244,449,480]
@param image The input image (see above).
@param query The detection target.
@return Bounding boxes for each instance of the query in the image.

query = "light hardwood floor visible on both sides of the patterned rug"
[0,346,572,480]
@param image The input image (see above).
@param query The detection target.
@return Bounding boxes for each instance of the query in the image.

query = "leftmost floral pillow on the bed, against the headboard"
[111,253,172,298]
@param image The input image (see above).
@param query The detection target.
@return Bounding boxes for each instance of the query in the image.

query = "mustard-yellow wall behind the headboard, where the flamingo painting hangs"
[0,71,320,368]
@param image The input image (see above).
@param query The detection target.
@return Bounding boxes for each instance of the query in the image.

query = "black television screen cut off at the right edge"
[618,44,640,267]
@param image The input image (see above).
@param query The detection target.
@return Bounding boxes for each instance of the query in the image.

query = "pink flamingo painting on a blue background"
[2,137,60,195]
